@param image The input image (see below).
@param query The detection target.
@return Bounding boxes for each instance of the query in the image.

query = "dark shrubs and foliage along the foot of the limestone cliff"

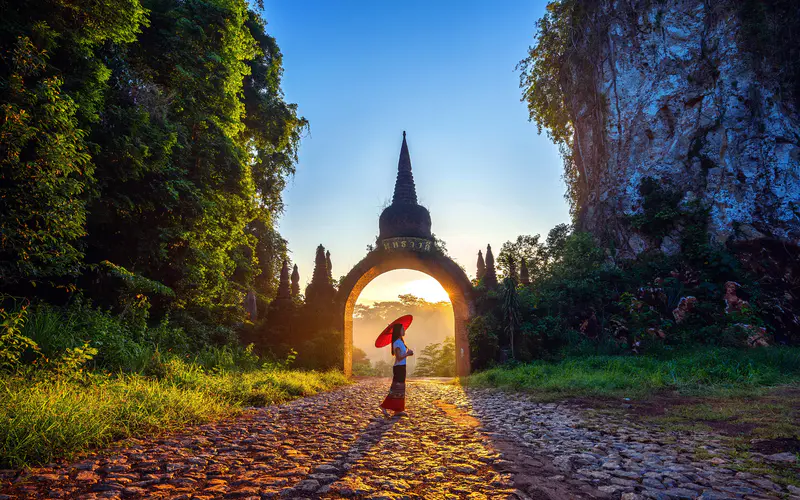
[468,207,800,369]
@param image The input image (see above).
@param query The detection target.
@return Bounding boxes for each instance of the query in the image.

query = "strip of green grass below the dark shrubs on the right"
[462,347,800,397]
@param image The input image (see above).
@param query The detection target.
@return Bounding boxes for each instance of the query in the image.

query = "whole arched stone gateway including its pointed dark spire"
[336,132,475,376]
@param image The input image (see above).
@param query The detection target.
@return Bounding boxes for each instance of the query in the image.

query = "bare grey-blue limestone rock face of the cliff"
[568,0,800,256]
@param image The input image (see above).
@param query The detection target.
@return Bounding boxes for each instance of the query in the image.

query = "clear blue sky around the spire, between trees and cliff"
[264,0,569,296]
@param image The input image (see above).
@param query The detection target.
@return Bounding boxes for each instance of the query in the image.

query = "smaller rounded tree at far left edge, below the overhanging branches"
[0,36,94,285]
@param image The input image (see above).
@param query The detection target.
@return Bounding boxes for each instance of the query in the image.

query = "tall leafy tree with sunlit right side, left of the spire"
[81,0,306,324]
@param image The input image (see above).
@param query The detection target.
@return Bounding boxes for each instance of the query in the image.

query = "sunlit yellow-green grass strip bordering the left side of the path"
[0,360,348,468]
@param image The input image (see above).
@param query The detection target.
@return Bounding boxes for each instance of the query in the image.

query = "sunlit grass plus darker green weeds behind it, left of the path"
[0,301,348,468]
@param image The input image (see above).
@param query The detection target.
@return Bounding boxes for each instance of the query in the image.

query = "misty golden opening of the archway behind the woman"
[352,269,456,377]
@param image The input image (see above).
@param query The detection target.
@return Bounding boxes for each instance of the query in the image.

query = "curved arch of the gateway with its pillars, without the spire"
[336,250,475,376]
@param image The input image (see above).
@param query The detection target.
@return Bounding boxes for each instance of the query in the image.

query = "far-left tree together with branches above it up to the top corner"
[0,0,146,286]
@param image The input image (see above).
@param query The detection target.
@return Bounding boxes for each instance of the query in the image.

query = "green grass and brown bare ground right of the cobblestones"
[461,347,800,486]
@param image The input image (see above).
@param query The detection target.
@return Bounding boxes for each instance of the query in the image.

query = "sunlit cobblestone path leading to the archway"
[0,380,800,500]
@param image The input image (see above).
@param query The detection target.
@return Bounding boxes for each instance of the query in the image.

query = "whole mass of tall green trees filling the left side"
[0,0,306,336]
